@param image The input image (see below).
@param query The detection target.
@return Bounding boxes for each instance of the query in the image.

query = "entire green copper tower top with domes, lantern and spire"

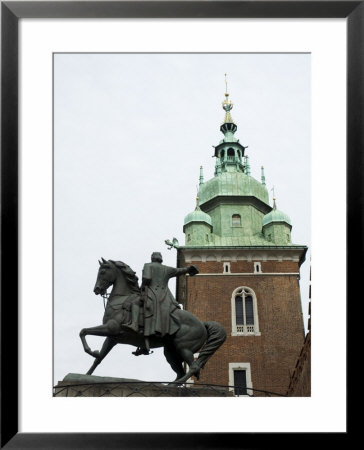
[179,81,302,248]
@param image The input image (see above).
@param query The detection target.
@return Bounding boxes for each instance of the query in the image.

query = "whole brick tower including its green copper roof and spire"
[177,86,307,395]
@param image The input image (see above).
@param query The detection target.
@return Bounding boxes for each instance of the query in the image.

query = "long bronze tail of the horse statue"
[190,322,226,379]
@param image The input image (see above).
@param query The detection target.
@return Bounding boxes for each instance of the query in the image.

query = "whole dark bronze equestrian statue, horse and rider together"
[80,252,226,383]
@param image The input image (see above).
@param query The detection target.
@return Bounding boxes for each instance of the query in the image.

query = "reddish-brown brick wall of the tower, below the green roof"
[179,258,304,395]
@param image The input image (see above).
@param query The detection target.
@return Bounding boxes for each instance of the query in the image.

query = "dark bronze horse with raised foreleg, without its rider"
[80,258,226,383]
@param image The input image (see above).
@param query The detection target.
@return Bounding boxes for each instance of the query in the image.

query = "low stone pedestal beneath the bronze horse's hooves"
[53,373,233,397]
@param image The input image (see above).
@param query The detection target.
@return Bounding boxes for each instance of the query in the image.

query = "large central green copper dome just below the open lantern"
[198,172,269,205]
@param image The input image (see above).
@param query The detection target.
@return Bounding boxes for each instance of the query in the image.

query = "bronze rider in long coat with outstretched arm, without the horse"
[125,252,198,337]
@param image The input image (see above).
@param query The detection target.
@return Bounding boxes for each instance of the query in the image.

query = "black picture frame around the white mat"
[1,0,356,449]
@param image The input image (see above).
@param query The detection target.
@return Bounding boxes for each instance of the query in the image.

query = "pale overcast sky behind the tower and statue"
[54,54,311,382]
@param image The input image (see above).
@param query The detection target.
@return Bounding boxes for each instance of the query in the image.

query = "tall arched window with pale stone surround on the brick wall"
[231,286,260,336]
